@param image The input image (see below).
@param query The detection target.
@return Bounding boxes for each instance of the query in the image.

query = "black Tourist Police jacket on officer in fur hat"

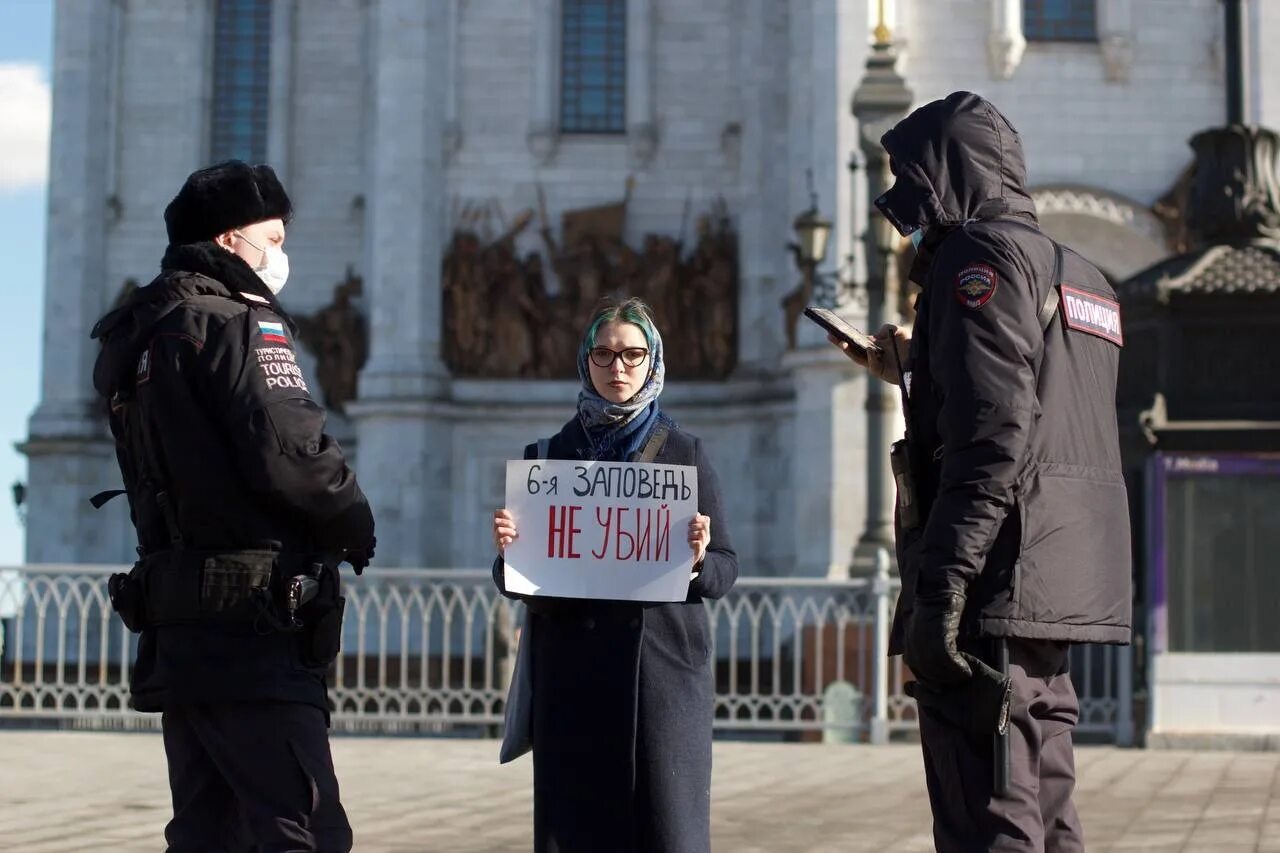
[93,243,374,711]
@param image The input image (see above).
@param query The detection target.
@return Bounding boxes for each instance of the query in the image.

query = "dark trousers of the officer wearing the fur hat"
[164,702,352,853]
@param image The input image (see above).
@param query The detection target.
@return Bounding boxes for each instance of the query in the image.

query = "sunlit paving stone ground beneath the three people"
[0,730,1280,853]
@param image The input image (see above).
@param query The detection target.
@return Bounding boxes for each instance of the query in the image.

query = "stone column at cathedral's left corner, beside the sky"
[22,0,119,562]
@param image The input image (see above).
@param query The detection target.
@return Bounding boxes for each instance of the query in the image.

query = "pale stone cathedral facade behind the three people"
[24,0,1254,575]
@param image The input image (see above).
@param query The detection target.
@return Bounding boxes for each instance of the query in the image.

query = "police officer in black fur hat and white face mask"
[93,161,374,852]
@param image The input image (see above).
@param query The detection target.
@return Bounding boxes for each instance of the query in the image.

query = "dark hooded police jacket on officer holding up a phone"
[877,92,1132,652]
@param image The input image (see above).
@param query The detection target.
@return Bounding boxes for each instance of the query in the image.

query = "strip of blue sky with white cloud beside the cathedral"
[0,0,54,565]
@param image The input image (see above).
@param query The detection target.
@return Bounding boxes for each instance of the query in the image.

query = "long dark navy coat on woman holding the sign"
[493,419,737,853]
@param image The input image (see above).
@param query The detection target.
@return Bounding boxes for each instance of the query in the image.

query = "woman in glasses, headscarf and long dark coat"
[493,298,737,853]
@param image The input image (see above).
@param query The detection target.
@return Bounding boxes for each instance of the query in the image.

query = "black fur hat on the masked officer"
[164,160,293,246]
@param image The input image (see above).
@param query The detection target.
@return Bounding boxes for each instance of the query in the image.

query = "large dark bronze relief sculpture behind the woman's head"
[442,192,739,379]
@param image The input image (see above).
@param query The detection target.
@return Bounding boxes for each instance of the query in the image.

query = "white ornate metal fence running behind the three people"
[0,561,1133,743]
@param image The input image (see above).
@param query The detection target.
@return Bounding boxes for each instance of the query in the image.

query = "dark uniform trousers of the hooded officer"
[920,639,1084,853]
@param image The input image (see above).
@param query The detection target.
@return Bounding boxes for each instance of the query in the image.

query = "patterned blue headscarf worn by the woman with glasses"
[577,329,671,462]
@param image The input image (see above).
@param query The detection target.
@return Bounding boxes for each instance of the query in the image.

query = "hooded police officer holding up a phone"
[834,92,1132,852]
